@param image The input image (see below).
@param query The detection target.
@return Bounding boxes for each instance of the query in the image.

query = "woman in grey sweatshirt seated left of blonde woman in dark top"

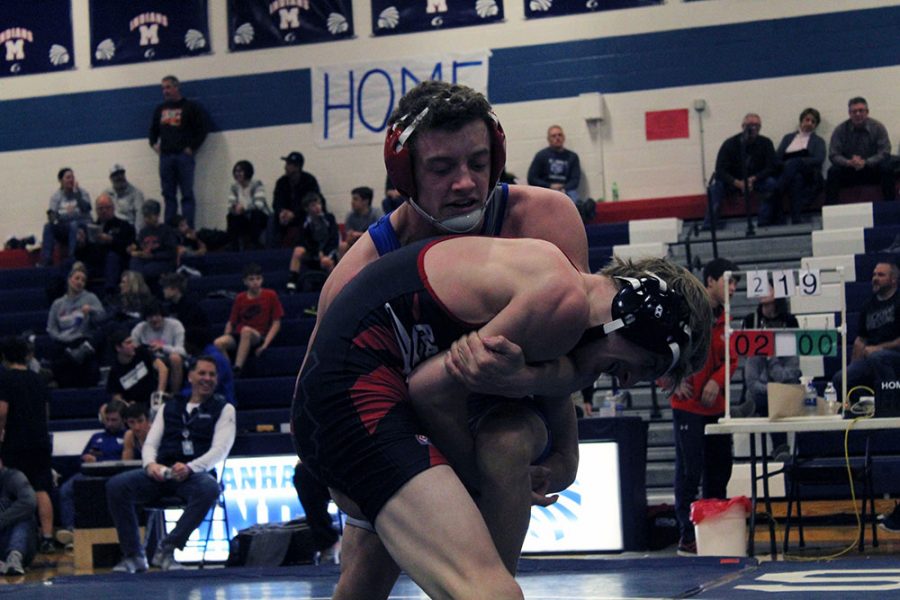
[47,262,106,387]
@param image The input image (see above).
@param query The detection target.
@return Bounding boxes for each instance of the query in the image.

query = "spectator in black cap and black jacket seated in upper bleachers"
[272,152,319,248]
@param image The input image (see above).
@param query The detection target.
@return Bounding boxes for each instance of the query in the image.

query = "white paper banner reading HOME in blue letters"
[312,51,490,148]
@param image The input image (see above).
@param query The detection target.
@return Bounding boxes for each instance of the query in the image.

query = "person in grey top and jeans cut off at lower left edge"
[0,464,37,575]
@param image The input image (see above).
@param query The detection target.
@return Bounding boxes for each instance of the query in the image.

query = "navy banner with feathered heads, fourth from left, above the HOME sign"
[372,0,503,35]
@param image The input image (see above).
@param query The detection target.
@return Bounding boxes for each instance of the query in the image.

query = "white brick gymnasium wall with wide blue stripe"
[0,0,900,240]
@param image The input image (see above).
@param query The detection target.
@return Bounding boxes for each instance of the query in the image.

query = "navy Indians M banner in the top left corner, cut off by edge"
[0,0,75,77]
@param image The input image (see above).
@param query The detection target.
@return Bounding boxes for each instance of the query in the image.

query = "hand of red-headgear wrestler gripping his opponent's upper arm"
[444,331,525,398]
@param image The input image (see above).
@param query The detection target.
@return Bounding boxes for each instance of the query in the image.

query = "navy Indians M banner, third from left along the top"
[228,0,353,52]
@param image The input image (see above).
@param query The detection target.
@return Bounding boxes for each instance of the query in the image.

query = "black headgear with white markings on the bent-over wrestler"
[579,272,691,373]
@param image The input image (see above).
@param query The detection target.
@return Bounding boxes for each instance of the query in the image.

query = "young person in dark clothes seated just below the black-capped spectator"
[287,192,340,292]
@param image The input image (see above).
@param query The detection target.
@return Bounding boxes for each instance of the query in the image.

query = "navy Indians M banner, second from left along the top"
[90,0,210,67]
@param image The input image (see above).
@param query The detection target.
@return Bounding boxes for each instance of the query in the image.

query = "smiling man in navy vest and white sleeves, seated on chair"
[106,355,235,573]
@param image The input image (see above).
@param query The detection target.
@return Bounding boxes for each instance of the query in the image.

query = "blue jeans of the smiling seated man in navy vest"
[106,469,219,556]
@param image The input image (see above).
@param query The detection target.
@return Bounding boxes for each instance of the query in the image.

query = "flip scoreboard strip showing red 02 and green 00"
[731,329,838,356]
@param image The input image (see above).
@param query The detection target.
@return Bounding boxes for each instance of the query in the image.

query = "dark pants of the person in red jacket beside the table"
[672,409,732,541]
